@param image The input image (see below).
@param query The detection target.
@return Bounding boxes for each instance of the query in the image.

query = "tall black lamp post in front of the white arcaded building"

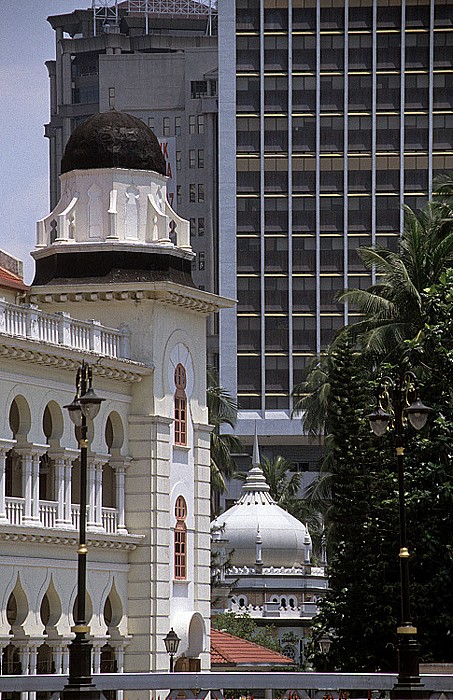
[63,361,104,700]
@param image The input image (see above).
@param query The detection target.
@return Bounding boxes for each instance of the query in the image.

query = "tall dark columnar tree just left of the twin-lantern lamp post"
[313,340,399,671]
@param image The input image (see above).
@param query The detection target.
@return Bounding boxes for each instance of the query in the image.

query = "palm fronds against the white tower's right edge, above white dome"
[206,367,242,510]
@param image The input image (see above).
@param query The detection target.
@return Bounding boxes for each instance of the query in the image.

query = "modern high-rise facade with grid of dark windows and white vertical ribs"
[219,0,453,464]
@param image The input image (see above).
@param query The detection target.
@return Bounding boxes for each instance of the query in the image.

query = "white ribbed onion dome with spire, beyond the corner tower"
[216,466,311,567]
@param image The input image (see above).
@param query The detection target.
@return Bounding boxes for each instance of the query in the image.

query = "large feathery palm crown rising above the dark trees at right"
[339,198,453,360]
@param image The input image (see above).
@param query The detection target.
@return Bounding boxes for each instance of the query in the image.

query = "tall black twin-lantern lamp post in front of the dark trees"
[368,372,432,698]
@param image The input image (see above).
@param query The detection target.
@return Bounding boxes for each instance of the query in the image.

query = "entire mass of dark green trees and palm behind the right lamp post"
[302,187,453,671]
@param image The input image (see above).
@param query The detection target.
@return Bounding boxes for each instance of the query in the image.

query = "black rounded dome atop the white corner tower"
[61,110,166,175]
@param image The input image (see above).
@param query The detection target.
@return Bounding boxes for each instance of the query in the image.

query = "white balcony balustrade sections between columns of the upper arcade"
[5,496,118,535]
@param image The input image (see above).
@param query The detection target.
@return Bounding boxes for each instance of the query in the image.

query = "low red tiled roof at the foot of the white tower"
[211,629,294,666]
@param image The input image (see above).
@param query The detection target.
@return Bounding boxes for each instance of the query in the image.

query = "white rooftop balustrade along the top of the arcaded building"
[0,299,130,359]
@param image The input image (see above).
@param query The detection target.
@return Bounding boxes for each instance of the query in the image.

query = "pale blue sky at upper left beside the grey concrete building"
[0,0,91,283]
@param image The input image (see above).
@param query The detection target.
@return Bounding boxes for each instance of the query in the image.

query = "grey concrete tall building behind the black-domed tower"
[45,0,217,310]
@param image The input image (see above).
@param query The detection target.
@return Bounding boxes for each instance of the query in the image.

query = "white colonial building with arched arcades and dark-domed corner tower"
[0,111,230,698]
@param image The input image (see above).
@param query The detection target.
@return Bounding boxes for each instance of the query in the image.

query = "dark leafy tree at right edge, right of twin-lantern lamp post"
[400,270,453,661]
